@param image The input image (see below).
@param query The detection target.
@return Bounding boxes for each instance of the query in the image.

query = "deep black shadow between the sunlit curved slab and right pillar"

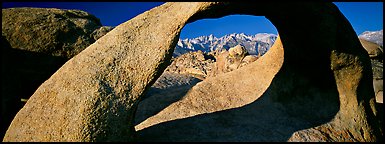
[137,5,340,138]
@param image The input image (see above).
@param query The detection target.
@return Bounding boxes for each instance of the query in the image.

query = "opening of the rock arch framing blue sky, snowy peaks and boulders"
[135,15,277,130]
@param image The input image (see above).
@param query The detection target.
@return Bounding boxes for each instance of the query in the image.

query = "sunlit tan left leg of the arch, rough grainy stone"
[4,3,206,141]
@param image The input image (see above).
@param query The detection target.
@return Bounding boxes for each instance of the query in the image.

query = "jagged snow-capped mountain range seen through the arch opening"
[174,33,277,56]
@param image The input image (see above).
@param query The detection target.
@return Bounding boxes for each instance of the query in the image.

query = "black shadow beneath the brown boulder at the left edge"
[1,36,68,138]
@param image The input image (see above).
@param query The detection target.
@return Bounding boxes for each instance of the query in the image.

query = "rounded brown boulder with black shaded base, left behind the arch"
[0,8,111,140]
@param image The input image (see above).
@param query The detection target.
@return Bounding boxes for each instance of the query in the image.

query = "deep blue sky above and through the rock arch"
[2,2,383,39]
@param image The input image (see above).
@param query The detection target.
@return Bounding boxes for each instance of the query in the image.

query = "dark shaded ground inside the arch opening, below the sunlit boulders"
[134,78,201,125]
